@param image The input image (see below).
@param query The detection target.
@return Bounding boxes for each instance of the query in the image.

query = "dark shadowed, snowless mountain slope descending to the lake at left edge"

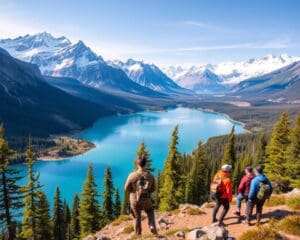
[0,49,111,136]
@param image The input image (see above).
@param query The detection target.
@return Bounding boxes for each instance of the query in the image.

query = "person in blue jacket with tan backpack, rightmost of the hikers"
[244,165,273,226]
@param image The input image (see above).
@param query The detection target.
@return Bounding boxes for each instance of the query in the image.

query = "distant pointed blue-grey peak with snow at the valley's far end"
[164,67,227,94]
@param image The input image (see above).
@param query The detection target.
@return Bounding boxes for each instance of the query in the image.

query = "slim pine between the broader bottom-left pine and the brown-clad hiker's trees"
[102,167,114,226]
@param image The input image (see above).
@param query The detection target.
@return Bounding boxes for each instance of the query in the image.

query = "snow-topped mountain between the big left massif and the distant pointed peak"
[110,59,191,94]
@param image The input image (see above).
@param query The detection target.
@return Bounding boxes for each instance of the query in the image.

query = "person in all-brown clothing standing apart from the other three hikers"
[125,156,157,235]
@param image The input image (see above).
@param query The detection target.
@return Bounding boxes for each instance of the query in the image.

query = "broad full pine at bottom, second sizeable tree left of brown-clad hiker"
[78,164,100,238]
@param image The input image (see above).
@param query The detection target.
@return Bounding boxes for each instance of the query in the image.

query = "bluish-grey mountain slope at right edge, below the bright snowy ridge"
[230,61,300,101]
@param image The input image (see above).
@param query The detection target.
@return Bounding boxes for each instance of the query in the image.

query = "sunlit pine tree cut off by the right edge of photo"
[286,114,300,188]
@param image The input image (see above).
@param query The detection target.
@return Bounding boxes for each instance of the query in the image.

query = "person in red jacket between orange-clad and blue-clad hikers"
[233,166,254,217]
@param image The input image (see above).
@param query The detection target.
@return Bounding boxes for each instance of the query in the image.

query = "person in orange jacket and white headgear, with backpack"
[210,164,232,225]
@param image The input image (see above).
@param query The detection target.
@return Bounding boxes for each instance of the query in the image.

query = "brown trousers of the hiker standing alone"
[131,199,156,235]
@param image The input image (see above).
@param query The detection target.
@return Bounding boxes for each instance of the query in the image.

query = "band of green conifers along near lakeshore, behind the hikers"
[0,112,300,240]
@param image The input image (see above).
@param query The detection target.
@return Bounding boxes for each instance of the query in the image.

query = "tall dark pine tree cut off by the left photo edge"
[0,125,23,240]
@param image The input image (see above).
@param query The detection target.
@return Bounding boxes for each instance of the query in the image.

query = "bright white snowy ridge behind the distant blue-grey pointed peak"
[162,54,300,86]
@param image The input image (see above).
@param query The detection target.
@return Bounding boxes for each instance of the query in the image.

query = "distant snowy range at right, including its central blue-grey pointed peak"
[162,54,300,92]
